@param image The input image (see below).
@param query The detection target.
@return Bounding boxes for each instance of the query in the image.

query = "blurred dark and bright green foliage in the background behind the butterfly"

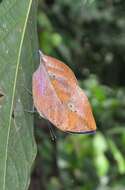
[31,0,125,190]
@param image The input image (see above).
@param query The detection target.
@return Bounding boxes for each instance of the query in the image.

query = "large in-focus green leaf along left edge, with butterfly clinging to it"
[0,0,38,190]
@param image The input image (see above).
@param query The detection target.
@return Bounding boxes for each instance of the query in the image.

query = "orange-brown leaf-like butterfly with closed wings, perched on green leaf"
[32,51,96,133]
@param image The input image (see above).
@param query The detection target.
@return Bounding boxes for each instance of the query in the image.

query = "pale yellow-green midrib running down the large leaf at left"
[2,0,32,190]
